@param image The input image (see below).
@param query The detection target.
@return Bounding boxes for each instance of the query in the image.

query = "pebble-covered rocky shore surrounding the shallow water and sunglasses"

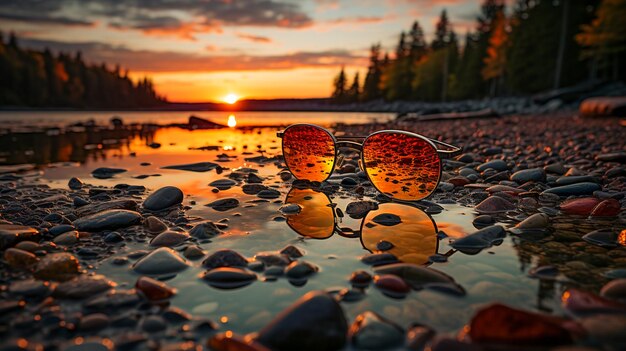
[0,112,626,351]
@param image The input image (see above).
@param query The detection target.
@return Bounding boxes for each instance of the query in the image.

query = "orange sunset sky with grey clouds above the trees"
[0,0,488,102]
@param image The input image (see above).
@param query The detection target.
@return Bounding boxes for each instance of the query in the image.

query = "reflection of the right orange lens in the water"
[361,203,439,264]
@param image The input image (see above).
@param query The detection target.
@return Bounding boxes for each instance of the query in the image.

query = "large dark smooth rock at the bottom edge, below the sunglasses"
[257,291,348,351]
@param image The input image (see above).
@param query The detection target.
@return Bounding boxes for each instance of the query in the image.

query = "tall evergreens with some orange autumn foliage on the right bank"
[331,0,626,103]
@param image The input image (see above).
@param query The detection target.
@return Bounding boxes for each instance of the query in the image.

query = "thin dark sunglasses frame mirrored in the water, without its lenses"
[285,187,456,266]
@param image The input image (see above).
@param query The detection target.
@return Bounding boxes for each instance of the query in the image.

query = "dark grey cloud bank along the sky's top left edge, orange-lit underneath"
[0,0,313,39]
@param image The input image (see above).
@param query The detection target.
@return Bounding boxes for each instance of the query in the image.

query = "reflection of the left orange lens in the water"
[285,188,335,239]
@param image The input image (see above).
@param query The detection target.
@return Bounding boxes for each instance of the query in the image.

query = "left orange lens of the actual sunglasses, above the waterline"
[283,125,335,182]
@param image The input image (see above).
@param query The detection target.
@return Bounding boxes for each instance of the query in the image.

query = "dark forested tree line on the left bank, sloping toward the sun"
[0,33,165,108]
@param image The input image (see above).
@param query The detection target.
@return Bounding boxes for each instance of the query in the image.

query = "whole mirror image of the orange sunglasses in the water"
[285,188,453,264]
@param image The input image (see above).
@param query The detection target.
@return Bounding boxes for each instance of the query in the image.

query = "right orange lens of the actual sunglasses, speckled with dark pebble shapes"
[363,132,441,200]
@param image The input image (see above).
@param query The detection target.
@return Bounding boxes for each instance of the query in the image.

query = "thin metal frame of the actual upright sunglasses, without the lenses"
[276,123,463,202]
